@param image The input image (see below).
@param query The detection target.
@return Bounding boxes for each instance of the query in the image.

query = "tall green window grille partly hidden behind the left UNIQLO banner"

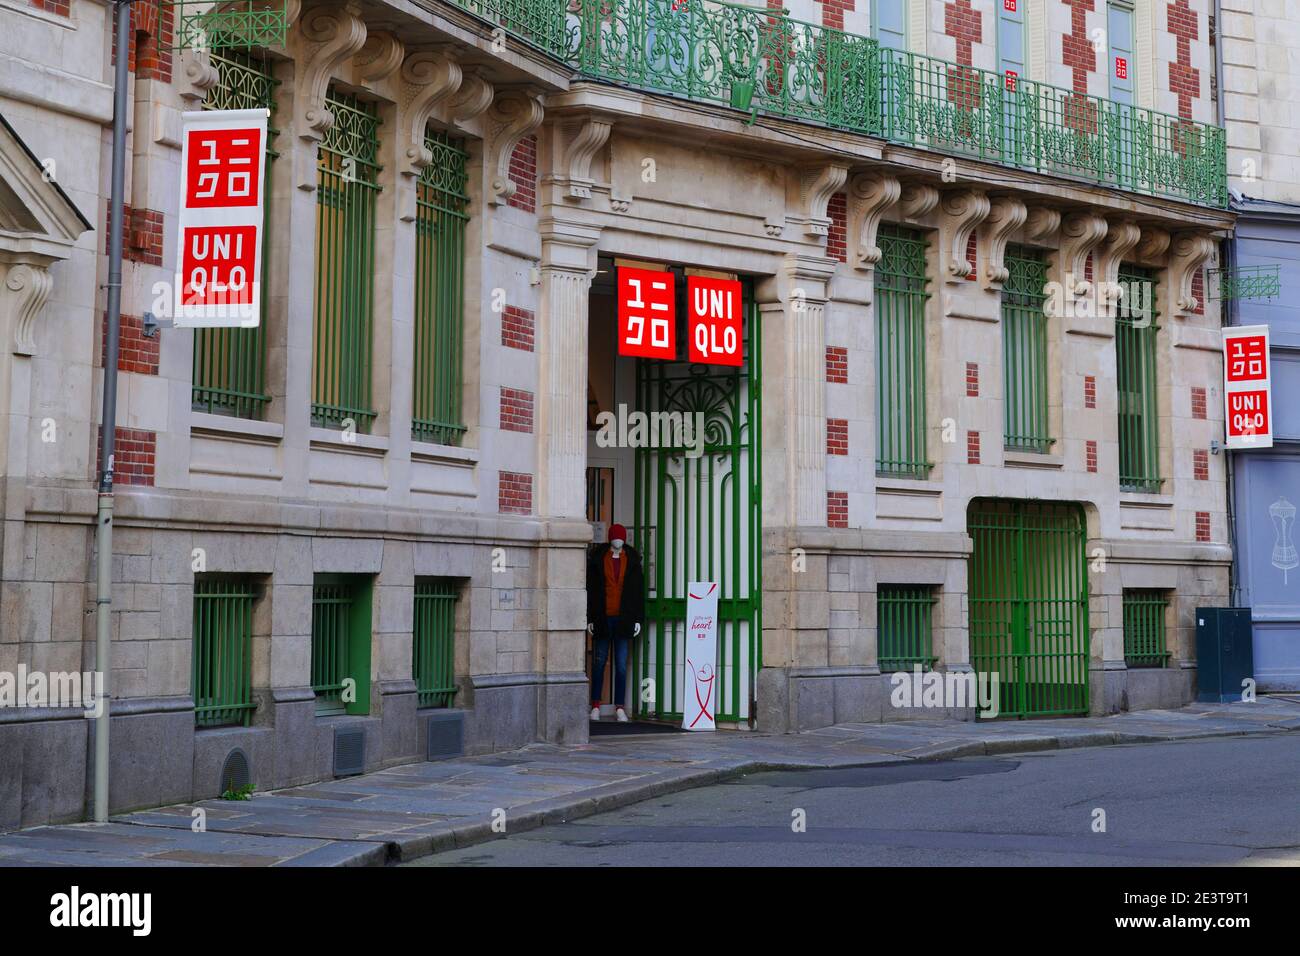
[191,49,276,419]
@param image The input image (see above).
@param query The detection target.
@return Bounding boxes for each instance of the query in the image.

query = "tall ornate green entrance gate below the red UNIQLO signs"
[631,273,762,723]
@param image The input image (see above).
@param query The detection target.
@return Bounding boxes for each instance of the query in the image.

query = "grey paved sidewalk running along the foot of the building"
[0,696,1300,866]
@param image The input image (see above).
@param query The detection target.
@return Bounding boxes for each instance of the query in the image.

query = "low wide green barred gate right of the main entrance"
[967,498,1088,717]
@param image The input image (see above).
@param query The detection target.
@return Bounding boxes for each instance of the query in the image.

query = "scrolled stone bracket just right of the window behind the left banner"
[294,0,365,190]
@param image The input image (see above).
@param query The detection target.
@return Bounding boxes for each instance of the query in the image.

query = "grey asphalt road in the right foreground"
[411,734,1300,866]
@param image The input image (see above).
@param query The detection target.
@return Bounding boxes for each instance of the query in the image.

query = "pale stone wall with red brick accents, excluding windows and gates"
[0,0,1232,827]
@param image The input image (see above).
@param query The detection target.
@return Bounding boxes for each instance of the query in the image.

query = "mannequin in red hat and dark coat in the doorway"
[586,524,645,722]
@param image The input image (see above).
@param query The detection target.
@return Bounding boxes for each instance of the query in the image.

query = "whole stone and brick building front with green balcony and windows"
[0,0,1234,827]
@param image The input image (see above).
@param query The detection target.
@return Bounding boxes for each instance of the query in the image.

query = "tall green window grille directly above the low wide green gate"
[1002,246,1053,451]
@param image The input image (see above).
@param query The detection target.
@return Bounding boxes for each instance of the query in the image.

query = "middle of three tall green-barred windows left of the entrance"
[312,88,381,432]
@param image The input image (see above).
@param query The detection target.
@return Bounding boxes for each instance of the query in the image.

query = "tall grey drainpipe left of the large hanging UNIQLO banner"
[95,0,131,823]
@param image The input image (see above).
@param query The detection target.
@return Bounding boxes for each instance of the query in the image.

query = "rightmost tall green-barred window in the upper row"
[1115,263,1161,492]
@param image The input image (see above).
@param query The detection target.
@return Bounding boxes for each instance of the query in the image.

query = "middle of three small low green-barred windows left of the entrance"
[312,575,371,714]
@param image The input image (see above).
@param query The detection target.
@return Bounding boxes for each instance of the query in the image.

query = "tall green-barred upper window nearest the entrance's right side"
[875,224,930,477]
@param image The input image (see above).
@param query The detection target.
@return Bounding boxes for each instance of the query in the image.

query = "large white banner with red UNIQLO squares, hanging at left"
[173,109,268,328]
